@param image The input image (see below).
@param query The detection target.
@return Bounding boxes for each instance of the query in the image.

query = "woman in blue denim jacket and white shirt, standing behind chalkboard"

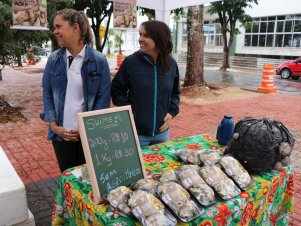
[41,9,111,172]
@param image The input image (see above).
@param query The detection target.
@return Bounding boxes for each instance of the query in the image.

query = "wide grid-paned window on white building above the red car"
[244,14,301,48]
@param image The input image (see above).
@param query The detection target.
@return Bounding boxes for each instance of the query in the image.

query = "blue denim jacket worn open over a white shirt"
[40,45,111,141]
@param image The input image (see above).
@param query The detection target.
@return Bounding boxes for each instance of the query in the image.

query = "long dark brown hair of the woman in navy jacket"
[141,20,172,73]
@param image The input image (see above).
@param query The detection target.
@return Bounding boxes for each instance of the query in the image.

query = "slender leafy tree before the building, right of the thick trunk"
[208,0,258,71]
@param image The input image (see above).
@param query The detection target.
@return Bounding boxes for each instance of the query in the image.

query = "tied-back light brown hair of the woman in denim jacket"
[55,9,93,46]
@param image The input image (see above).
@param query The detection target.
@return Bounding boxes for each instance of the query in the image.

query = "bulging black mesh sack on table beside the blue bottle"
[225,118,295,173]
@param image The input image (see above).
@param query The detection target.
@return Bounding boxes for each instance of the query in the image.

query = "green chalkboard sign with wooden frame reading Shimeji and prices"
[77,106,146,203]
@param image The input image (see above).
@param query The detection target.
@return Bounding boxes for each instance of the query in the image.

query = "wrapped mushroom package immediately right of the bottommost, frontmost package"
[156,181,201,222]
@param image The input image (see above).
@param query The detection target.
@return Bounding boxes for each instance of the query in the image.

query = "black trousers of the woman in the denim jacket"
[52,141,86,172]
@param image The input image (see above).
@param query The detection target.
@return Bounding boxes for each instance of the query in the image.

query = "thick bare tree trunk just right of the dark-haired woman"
[184,5,206,87]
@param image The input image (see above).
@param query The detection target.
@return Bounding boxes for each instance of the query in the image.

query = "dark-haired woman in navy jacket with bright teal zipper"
[111,21,180,147]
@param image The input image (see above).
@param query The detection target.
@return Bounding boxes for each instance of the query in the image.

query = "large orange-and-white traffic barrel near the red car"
[257,64,276,93]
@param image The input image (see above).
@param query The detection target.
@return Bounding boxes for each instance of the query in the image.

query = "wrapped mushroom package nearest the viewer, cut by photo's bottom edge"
[124,190,177,226]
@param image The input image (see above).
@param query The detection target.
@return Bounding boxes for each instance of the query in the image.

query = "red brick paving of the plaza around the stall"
[0,66,301,226]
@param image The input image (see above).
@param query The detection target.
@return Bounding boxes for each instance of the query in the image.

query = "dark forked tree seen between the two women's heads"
[73,0,113,52]
